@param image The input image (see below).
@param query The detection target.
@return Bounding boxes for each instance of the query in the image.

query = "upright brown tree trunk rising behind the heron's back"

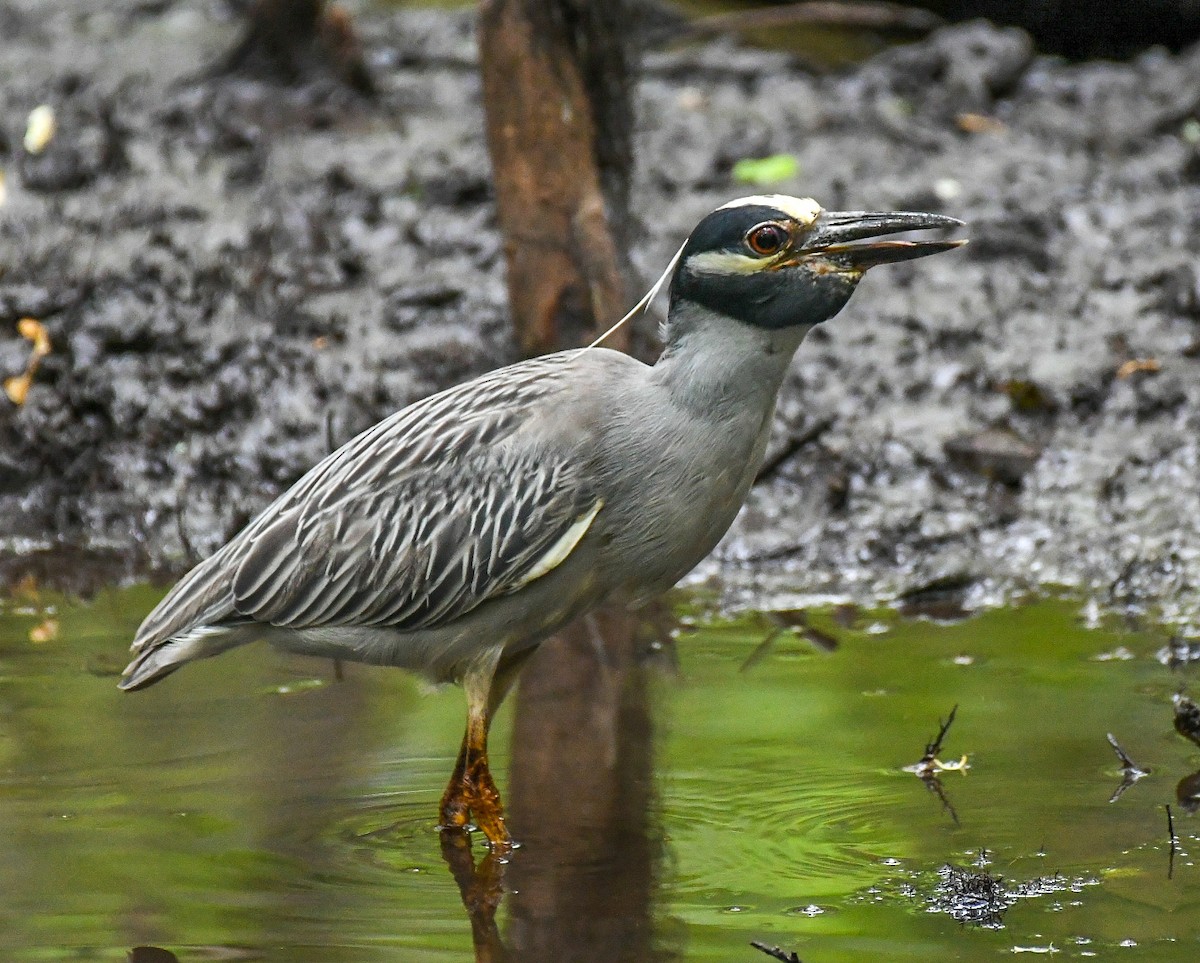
[479,0,632,354]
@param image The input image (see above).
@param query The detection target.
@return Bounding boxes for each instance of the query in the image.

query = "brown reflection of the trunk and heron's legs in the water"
[443,608,661,963]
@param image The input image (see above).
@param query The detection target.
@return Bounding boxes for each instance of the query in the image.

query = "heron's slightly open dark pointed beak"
[792,211,966,274]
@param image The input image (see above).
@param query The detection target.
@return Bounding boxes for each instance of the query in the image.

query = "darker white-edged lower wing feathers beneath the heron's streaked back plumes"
[233,451,596,630]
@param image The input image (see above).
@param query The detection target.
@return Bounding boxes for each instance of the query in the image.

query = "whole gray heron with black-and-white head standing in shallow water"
[121,196,962,848]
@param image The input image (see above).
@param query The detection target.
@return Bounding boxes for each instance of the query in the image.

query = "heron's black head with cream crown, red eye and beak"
[671,195,966,329]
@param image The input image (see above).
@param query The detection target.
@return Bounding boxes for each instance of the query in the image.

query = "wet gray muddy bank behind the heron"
[0,0,1200,624]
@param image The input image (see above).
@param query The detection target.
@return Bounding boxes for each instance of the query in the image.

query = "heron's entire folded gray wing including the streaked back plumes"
[133,352,599,652]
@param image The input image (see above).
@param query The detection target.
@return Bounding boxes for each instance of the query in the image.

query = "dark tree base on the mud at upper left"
[222,0,374,95]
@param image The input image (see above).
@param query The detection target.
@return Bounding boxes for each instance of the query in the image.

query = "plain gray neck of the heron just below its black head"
[650,300,811,415]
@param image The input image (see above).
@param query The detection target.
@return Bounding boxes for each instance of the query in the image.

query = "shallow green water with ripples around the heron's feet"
[0,588,1200,963]
